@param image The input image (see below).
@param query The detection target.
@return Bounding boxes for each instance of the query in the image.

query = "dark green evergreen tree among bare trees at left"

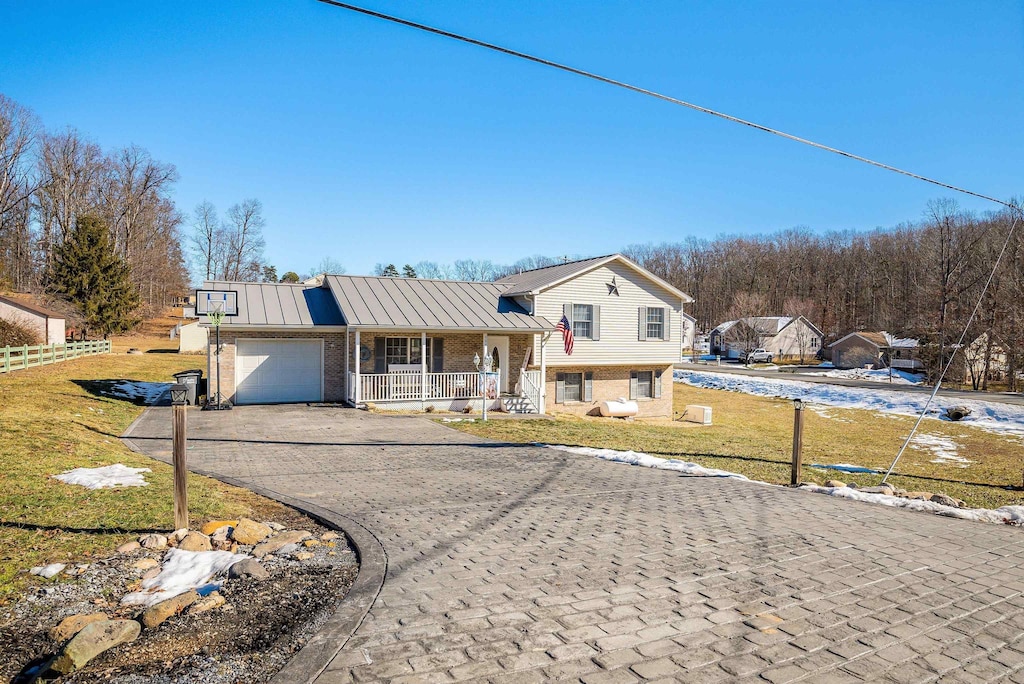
[51,215,141,338]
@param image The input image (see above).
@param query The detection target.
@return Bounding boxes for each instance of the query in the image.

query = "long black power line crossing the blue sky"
[317,0,1014,208]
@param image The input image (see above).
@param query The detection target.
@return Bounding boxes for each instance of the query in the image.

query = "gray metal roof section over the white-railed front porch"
[325,275,555,331]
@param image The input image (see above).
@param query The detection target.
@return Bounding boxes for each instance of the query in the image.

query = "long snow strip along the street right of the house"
[673,371,1024,437]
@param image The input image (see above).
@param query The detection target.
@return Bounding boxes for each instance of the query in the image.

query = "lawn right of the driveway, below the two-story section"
[450,383,1024,508]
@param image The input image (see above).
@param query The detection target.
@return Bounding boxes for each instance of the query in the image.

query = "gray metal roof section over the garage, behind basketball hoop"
[200,281,345,327]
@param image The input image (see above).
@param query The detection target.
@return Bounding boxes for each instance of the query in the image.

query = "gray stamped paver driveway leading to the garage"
[123,407,1024,684]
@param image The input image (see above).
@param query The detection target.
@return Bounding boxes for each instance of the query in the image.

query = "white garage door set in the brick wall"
[234,340,324,403]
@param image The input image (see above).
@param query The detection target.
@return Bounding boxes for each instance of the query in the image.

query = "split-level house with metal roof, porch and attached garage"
[201,254,690,417]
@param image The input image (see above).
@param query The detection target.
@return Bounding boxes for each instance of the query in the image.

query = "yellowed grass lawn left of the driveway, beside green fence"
[0,338,294,601]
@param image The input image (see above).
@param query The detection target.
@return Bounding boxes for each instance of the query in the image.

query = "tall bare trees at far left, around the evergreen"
[0,93,188,307]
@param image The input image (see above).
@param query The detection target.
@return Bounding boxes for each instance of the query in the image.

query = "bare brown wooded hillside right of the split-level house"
[625,200,1024,391]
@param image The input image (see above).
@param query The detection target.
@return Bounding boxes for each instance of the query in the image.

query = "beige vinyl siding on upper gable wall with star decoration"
[534,261,683,366]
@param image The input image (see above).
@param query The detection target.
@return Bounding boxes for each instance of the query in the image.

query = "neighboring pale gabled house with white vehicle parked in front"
[709,315,823,361]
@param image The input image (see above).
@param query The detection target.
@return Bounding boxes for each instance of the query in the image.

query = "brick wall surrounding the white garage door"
[208,328,345,403]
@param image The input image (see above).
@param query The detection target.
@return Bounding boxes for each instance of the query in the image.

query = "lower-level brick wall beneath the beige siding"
[545,365,674,418]
